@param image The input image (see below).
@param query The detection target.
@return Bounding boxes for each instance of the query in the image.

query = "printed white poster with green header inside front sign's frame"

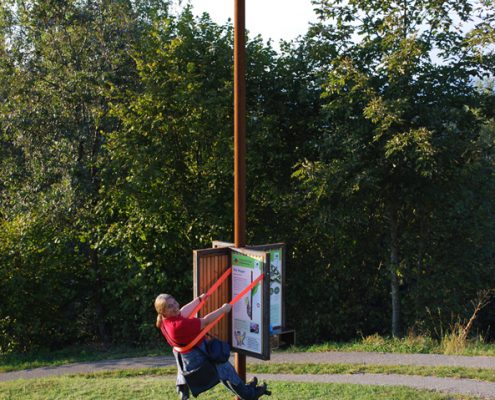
[232,252,263,354]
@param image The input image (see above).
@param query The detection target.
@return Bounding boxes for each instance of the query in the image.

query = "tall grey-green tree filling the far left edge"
[0,0,168,348]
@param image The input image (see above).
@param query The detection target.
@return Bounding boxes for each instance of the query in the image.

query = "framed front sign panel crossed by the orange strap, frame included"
[231,249,270,360]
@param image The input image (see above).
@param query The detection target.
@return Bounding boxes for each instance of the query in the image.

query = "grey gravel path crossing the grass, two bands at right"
[0,352,495,399]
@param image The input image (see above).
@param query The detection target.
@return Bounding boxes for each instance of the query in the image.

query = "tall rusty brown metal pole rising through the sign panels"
[234,0,246,394]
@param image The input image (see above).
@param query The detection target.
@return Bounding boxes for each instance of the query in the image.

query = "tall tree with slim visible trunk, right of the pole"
[297,0,494,336]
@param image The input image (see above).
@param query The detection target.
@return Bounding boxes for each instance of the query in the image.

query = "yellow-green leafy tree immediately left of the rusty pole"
[99,9,233,337]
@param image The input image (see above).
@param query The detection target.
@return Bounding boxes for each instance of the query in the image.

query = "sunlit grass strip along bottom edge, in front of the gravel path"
[0,375,475,400]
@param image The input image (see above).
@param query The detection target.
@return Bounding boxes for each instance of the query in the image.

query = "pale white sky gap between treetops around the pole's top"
[178,0,316,48]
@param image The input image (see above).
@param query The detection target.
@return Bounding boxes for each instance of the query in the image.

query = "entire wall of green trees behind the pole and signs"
[0,0,495,352]
